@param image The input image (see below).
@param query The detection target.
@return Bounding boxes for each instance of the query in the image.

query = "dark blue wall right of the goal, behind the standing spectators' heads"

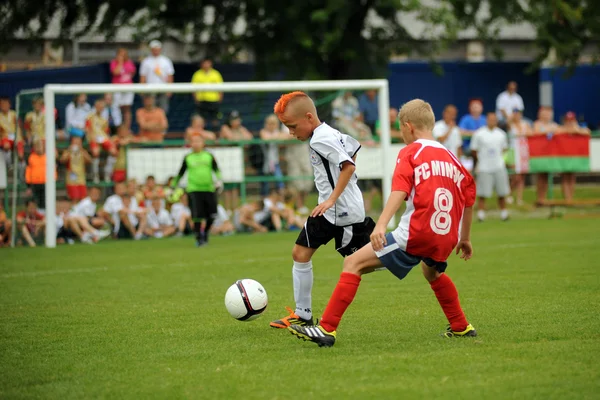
[388,63,539,122]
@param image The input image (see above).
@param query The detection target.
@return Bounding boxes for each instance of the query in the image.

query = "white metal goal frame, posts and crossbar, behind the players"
[44,79,394,248]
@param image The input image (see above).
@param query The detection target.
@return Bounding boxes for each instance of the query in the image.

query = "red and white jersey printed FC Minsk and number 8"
[392,139,475,262]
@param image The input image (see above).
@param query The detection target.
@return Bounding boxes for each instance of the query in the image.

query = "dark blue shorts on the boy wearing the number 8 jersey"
[375,233,448,279]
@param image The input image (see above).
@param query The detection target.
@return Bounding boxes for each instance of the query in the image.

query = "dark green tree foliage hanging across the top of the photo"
[0,0,600,79]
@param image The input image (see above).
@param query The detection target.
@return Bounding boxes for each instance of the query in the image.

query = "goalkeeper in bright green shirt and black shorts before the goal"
[169,136,223,246]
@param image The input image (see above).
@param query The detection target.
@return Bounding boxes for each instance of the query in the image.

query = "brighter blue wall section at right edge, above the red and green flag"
[540,65,600,129]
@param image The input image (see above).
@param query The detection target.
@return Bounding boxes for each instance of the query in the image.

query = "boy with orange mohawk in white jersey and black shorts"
[270,92,375,328]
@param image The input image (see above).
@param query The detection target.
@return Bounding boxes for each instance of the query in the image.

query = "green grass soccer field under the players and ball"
[0,217,600,399]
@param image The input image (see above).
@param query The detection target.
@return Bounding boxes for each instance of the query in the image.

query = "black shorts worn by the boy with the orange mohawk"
[296,216,375,257]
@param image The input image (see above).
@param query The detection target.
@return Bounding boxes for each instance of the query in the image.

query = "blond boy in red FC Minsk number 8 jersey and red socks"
[288,99,477,347]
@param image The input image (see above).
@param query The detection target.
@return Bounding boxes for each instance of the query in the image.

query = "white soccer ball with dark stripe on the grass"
[225,279,269,321]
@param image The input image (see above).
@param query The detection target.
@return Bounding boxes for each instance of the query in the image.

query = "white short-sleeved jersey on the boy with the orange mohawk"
[310,123,365,226]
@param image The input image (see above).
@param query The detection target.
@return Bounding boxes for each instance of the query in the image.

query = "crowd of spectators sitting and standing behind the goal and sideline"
[0,40,589,246]
